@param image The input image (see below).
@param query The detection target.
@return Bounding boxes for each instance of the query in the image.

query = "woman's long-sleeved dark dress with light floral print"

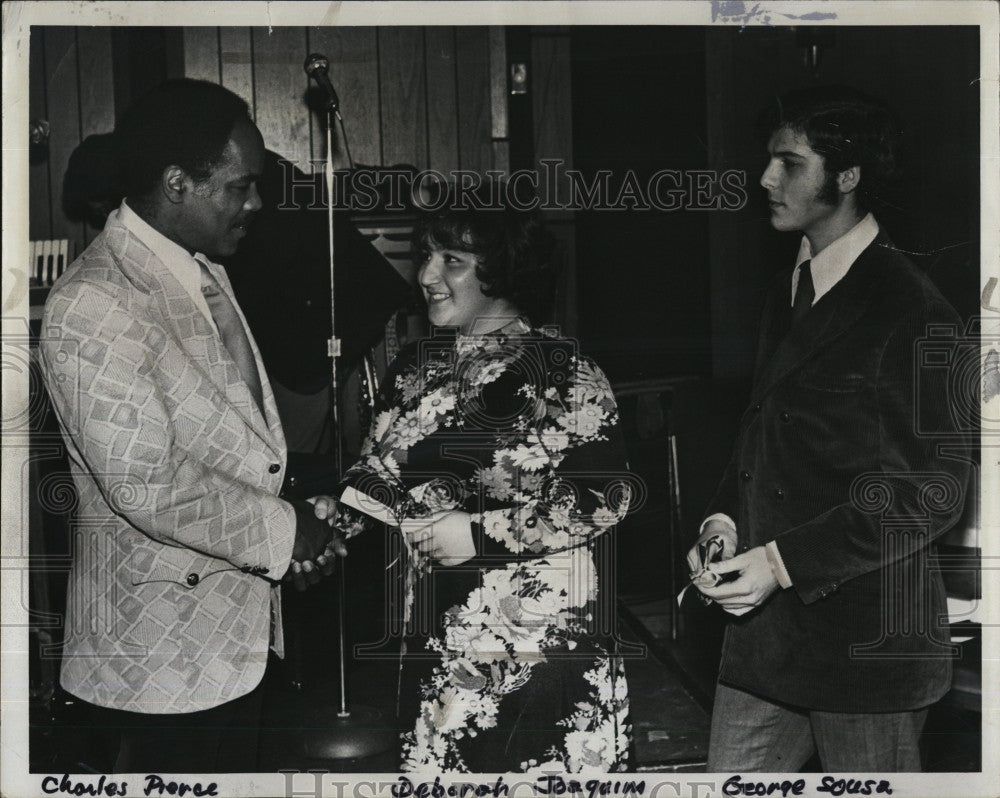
[340,320,630,773]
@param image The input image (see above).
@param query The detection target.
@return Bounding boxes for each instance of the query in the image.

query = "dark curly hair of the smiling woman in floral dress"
[413,180,557,325]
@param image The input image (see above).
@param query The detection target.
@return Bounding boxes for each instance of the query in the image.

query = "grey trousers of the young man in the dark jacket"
[708,684,927,773]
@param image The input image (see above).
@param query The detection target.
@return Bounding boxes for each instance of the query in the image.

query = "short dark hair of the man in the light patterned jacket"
[115,78,250,206]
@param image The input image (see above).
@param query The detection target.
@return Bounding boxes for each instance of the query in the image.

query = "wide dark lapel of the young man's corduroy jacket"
[750,233,891,404]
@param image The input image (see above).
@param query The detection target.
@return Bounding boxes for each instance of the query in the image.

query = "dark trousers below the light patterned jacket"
[92,685,264,773]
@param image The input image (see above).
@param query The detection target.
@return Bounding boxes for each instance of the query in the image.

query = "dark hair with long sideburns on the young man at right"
[761,86,898,211]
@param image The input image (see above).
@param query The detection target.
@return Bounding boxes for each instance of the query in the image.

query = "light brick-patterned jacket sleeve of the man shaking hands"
[39,282,295,579]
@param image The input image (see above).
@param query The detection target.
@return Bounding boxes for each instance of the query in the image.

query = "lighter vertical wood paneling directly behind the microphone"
[184,27,506,173]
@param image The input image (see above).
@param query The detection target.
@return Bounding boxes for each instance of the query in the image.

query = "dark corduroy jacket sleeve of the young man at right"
[776,308,968,603]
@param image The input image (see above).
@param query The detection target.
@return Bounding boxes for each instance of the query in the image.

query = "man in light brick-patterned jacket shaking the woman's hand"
[41,80,343,772]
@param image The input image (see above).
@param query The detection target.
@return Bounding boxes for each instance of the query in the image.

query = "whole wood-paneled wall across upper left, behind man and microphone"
[29,27,509,257]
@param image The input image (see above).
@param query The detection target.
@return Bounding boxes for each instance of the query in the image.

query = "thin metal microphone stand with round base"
[302,90,396,760]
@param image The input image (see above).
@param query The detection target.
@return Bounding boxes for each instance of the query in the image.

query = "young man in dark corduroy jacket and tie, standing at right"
[688,89,967,772]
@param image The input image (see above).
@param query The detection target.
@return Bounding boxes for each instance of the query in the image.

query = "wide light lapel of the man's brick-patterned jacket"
[105,215,284,455]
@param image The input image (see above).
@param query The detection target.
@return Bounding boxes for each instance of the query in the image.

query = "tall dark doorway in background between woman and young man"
[572,27,711,381]
